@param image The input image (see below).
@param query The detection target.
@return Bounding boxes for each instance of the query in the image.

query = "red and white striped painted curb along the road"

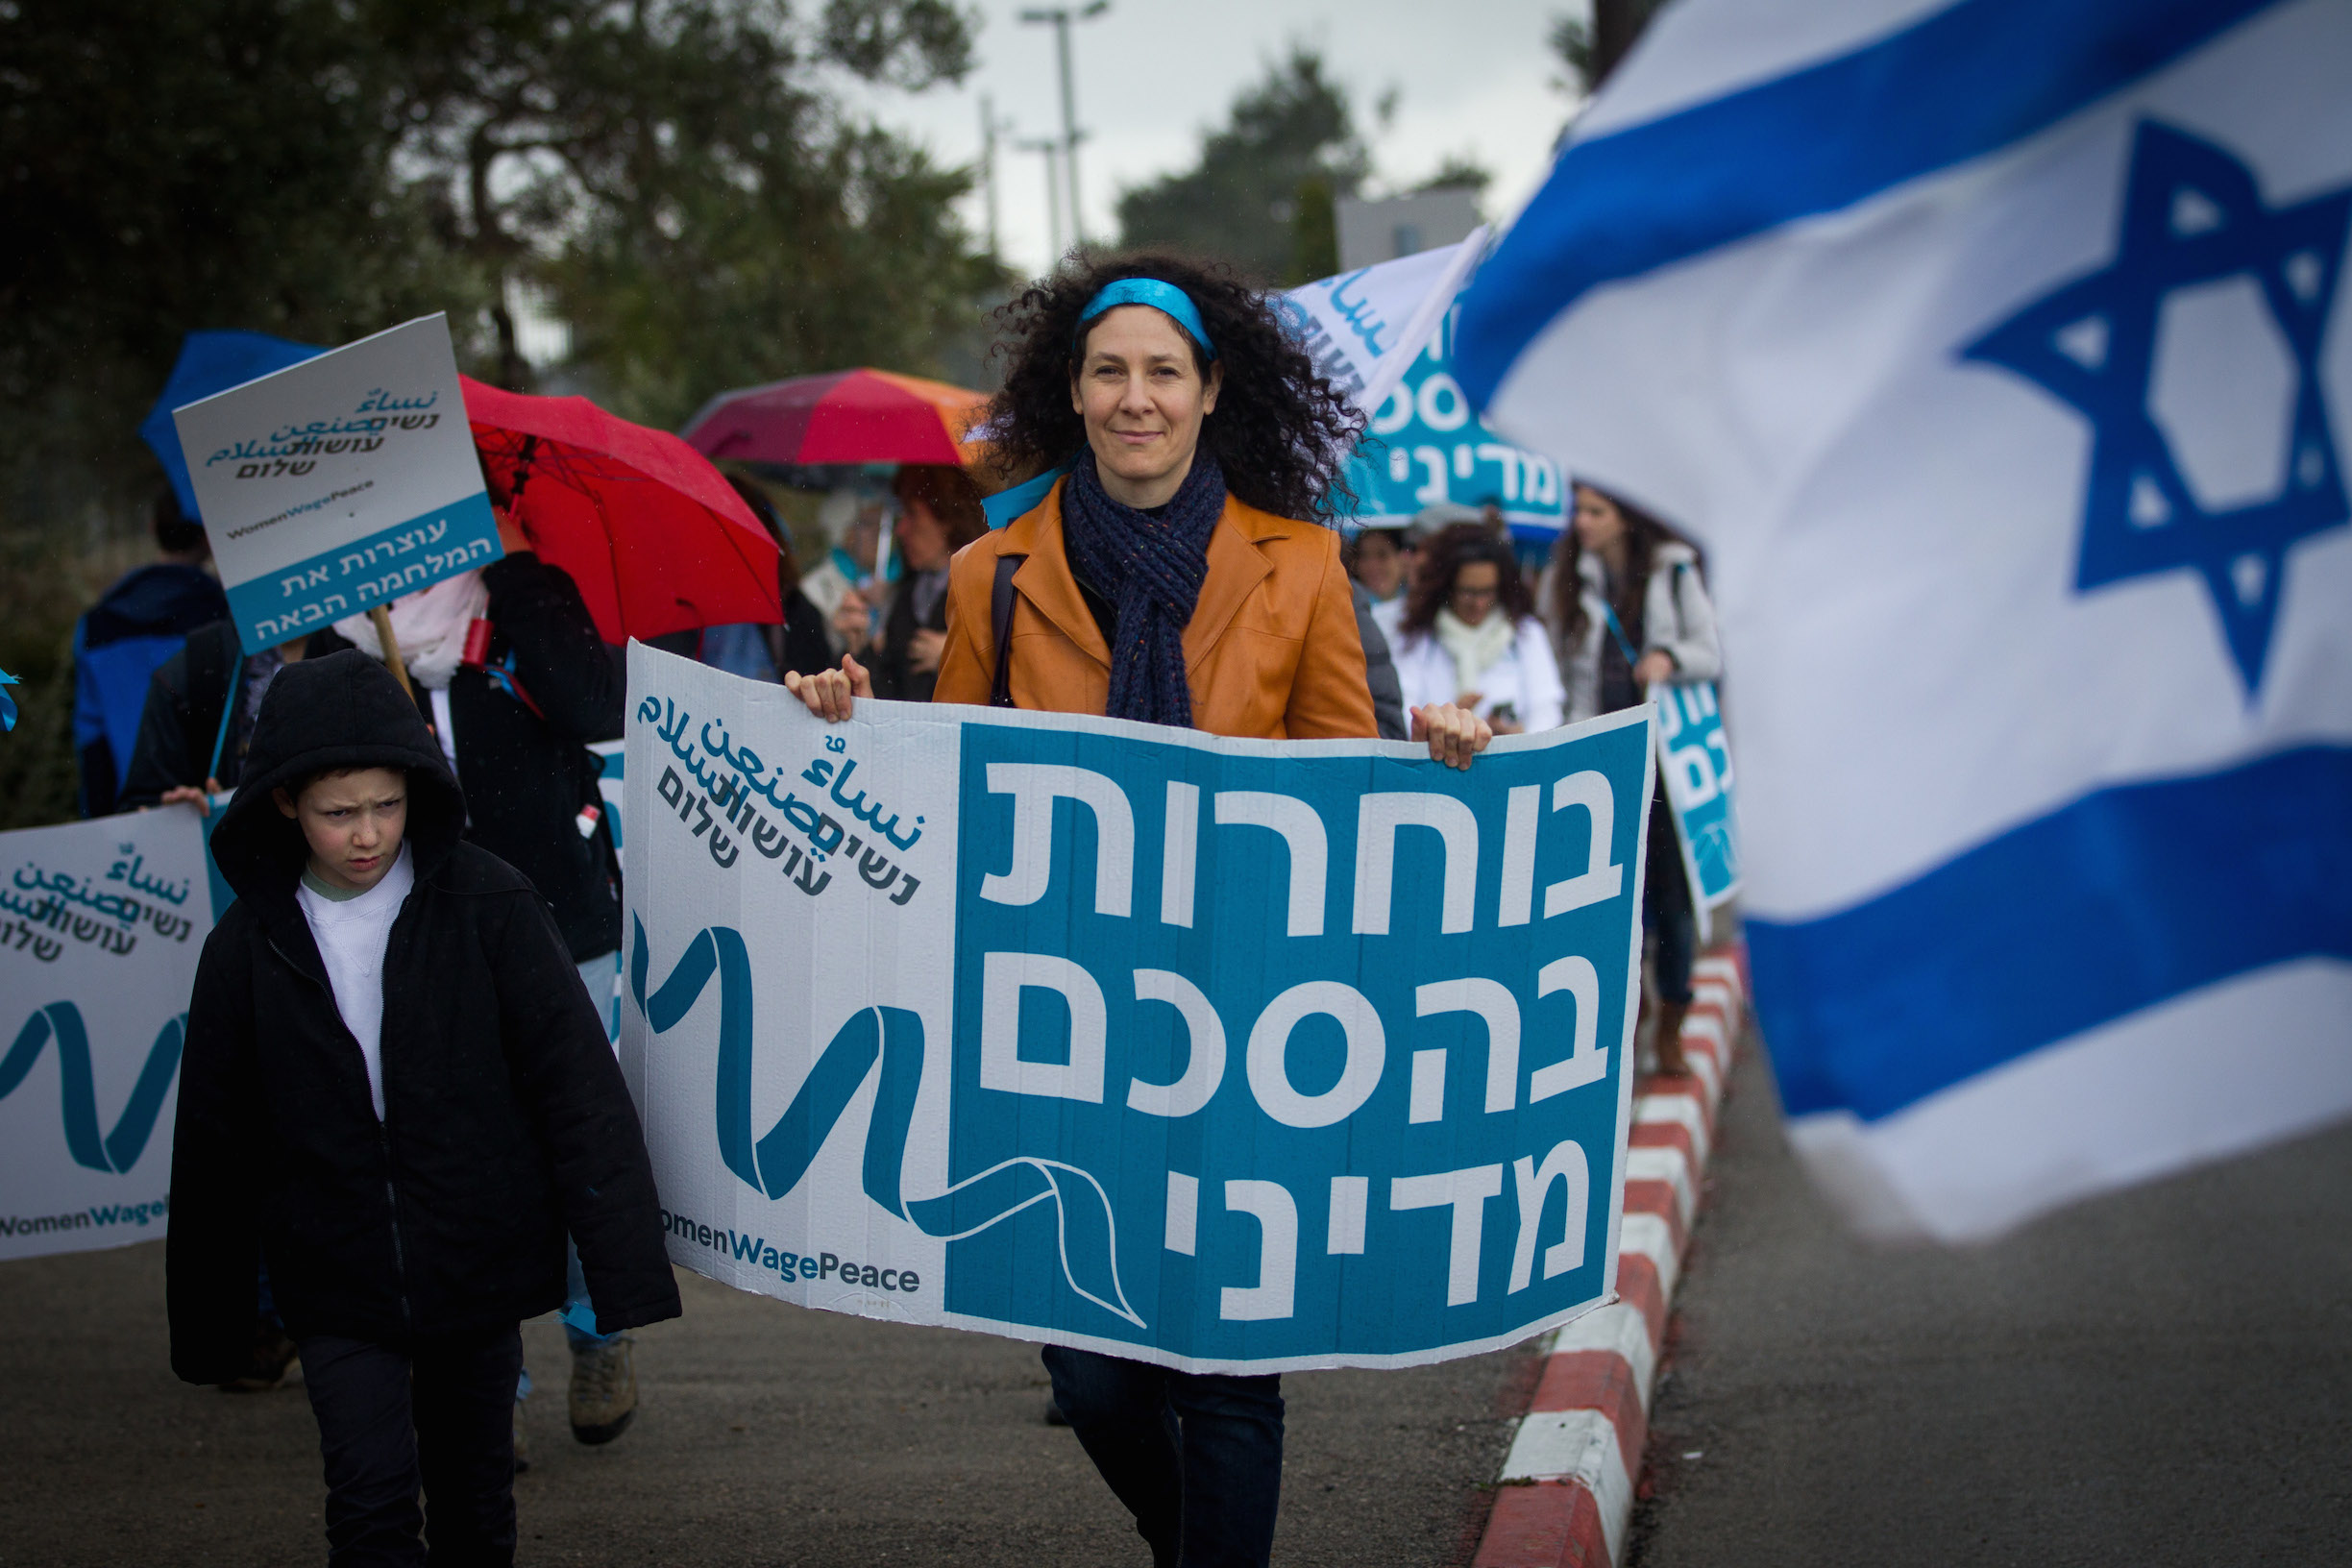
[1472,949,1748,1568]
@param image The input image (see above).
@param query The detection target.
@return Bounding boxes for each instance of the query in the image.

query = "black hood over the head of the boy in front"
[211,649,466,898]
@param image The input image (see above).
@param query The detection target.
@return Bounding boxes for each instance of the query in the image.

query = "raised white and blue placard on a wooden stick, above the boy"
[172,315,503,651]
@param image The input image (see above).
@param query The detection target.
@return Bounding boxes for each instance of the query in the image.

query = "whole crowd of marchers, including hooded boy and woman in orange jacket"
[55,257,1719,1566]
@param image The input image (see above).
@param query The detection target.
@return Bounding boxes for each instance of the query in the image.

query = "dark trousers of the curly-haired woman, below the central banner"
[1044,1345,1282,1568]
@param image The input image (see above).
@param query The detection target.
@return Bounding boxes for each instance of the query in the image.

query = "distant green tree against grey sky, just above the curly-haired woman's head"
[1117,44,1371,284]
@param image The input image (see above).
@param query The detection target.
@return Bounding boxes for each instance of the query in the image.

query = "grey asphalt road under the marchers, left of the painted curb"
[0,1243,1536,1568]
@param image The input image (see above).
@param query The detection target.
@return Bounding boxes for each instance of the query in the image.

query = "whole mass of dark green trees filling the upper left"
[0,0,1002,821]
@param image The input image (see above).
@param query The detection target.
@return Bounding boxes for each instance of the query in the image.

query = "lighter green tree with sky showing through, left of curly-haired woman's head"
[385,0,997,423]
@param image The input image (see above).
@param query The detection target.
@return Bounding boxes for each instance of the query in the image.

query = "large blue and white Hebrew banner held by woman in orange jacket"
[621,647,1654,1370]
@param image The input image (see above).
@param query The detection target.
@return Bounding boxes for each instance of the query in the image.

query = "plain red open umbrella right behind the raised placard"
[458,376,783,642]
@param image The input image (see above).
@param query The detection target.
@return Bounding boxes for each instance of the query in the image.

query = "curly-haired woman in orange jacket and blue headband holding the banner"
[793,257,1493,1568]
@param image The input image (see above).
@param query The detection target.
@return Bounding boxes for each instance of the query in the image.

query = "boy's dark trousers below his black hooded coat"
[301,1324,522,1568]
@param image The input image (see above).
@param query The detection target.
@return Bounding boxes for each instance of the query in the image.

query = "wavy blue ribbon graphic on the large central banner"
[625,919,1143,1328]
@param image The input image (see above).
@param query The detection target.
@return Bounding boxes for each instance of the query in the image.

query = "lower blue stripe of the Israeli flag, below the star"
[1748,746,2352,1121]
